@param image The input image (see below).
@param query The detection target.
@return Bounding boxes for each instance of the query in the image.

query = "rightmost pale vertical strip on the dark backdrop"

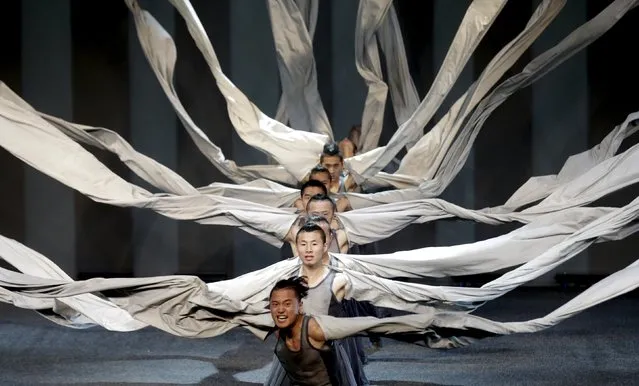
[531,1,589,285]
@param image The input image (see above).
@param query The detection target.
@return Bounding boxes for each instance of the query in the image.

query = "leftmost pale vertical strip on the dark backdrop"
[21,0,77,277]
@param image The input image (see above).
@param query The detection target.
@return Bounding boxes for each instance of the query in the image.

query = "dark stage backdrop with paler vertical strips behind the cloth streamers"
[0,0,639,284]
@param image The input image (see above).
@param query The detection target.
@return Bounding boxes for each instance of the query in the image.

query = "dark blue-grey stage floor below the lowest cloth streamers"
[0,289,639,385]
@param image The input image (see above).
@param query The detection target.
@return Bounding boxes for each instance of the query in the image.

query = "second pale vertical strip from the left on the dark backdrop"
[129,0,179,276]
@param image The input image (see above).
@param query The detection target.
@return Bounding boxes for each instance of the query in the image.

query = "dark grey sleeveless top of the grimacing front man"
[275,315,334,386]
